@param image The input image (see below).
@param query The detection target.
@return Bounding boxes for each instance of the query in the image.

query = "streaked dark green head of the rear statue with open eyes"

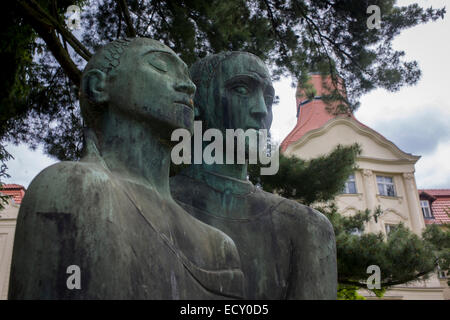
[190,52,274,131]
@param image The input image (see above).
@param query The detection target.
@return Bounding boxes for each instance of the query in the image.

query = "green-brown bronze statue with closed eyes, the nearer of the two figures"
[9,38,243,299]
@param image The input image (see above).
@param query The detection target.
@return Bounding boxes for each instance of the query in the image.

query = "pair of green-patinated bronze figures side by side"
[9,38,337,299]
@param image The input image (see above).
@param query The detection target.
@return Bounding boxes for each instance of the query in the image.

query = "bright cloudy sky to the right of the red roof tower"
[355,0,450,188]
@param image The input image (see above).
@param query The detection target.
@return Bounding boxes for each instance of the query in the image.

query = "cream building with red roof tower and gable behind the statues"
[281,74,443,299]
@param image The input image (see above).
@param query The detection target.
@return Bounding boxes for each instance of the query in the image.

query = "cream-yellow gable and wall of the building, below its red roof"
[285,118,444,299]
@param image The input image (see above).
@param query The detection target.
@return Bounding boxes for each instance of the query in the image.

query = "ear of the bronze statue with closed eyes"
[81,69,109,104]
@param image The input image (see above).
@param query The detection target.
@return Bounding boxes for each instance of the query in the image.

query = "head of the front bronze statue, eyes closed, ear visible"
[80,38,195,141]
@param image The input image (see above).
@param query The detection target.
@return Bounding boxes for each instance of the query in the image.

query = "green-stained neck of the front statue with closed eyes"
[99,112,171,199]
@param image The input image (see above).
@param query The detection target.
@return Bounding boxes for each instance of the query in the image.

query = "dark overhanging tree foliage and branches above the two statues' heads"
[0,0,445,160]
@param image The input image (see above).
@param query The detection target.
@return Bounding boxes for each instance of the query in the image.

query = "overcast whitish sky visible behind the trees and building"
[5,0,450,188]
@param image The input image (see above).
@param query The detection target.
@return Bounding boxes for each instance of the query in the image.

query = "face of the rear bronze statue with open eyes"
[209,53,274,131]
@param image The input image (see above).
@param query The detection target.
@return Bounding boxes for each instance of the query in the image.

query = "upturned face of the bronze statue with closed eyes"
[107,39,195,135]
